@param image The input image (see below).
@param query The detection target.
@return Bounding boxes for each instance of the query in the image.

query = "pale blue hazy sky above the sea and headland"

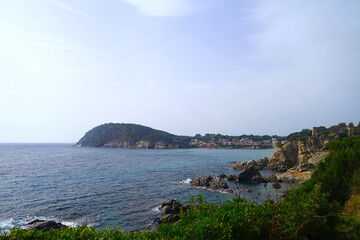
[0,0,360,143]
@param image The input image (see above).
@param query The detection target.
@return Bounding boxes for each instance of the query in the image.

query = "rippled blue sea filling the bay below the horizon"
[0,143,288,231]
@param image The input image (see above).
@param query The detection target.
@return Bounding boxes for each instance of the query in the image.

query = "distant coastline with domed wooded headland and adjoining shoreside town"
[75,123,286,149]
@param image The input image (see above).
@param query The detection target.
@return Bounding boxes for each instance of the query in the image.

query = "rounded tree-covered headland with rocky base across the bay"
[75,123,188,149]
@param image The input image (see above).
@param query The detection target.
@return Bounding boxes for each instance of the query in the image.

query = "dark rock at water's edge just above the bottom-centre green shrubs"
[154,199,190,224]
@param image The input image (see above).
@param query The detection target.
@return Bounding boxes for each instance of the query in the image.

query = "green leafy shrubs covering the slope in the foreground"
[0,137,360,240]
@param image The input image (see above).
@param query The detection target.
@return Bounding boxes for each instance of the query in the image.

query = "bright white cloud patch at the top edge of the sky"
[123,0,197,17]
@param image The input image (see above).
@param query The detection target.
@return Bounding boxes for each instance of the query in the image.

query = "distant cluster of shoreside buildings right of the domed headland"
[189,137,286,148]
